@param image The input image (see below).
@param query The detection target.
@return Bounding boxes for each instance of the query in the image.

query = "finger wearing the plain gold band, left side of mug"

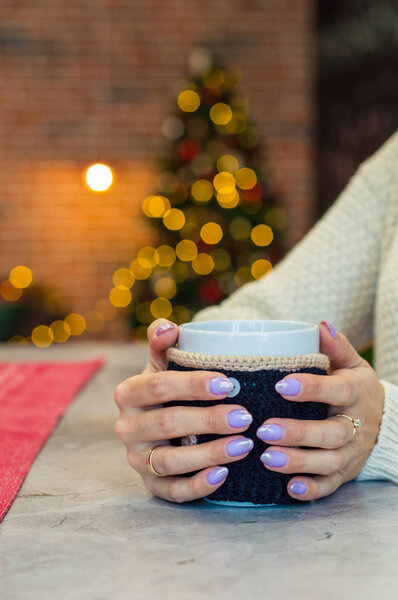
[139,436,254,475]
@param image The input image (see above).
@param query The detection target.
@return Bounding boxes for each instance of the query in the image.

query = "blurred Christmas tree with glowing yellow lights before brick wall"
[129,51,285,339]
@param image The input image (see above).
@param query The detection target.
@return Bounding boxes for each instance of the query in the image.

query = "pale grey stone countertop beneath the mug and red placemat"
[0,343,398,600]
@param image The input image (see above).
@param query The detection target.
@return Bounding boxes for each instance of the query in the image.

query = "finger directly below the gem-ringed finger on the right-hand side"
[260,446,352,475]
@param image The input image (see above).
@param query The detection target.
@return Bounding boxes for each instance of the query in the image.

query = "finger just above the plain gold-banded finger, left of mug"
[133,404,252,442]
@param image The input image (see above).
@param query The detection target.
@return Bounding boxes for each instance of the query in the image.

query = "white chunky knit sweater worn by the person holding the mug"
[194,132,398,483]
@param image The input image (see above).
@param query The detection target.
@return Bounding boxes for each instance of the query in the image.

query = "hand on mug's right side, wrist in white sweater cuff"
[257,321,384,500]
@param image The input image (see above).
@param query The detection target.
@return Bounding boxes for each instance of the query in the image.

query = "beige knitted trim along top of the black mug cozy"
[167,348,330,371]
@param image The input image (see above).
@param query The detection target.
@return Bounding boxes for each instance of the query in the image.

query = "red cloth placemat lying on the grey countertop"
[0,359,104,523]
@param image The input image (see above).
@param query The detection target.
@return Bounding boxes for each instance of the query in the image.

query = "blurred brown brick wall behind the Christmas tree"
[0,0,314,335]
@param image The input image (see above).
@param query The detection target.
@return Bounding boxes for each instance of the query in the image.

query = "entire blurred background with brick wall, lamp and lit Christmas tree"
[0,0,398,347]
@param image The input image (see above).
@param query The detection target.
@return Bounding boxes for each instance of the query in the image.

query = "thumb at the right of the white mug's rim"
[319,321,362,371]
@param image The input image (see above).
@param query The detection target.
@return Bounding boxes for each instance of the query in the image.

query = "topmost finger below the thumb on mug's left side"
[115,371,238,409]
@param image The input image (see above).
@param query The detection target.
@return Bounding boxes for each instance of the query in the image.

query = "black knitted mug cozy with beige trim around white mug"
[167,348,329,505]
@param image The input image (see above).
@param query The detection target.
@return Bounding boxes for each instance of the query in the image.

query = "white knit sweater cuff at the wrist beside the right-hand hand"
[356,379,398,483]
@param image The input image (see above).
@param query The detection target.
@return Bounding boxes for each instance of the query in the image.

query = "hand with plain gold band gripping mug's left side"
[115,319,253,502]
